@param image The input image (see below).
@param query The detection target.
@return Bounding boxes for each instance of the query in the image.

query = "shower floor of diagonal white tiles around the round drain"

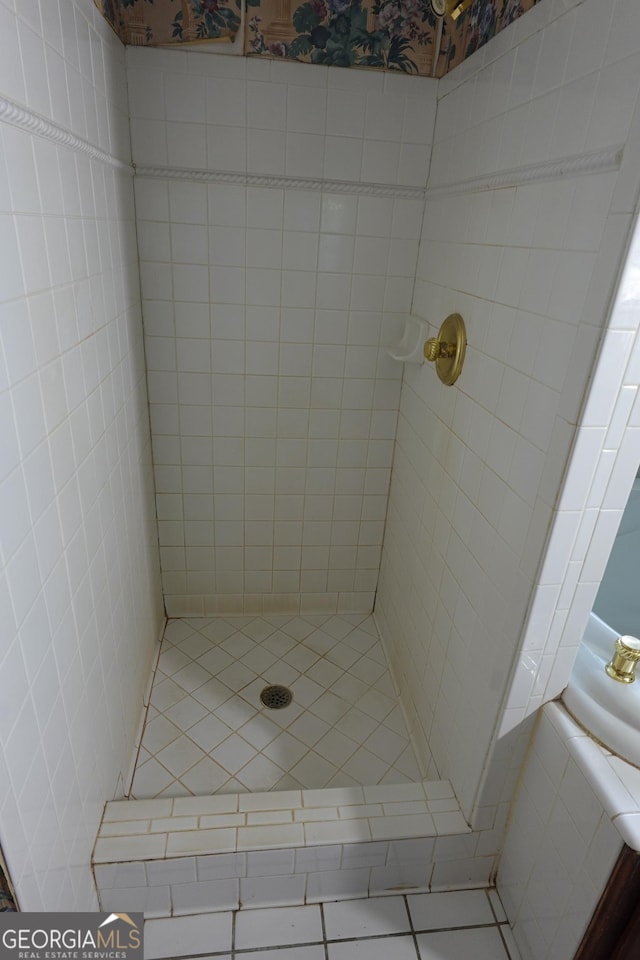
[131,614,420,799]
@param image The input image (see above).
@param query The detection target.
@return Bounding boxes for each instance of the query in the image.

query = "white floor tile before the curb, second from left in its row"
[234,906,323,950]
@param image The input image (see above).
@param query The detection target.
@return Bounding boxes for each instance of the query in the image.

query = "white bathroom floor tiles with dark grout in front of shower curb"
[136,892,519,960]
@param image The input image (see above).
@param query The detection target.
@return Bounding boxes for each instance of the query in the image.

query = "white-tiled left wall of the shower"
[0,0,167,912]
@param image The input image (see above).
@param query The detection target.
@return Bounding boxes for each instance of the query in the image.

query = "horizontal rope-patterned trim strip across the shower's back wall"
[134,164,425,200]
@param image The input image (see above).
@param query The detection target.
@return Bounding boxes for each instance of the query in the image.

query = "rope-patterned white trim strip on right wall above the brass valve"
[426,146,624,200]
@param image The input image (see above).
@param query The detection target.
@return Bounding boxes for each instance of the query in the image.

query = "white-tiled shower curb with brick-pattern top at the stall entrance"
[93,780,494,917]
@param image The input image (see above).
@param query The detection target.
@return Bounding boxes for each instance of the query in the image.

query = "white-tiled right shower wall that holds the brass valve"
[376,3,638,832]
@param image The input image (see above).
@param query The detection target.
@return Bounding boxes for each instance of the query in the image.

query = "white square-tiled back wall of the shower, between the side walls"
[127,49,436,615]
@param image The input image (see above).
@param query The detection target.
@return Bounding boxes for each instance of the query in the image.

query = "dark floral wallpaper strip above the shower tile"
[94,0,539,77]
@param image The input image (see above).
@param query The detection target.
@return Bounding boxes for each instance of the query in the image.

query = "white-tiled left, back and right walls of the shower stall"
[0,0,640,956]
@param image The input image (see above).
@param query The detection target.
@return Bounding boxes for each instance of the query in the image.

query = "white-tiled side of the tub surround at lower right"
[498,704,622,960]
